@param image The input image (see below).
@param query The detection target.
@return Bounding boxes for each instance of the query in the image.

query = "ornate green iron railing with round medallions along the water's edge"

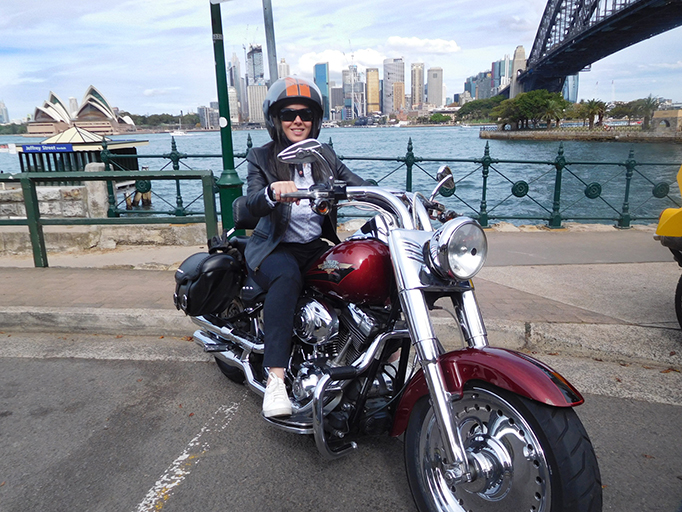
[97,136,681,228]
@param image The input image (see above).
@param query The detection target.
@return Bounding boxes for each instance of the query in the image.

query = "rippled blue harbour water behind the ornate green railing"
[0,127,682,224]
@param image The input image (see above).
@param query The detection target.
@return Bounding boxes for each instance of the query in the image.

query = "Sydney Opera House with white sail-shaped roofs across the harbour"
[28,85,135,136]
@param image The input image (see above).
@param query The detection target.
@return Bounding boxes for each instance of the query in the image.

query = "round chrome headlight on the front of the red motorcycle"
[429,217,488,281]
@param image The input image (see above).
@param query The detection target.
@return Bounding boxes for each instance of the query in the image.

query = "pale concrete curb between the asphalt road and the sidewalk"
[0,306,682,368]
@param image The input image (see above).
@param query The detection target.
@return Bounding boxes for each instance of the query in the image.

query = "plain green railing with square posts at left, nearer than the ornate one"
[0,170,218,267]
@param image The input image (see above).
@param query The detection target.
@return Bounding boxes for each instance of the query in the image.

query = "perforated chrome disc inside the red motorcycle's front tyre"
[419,388,551,512]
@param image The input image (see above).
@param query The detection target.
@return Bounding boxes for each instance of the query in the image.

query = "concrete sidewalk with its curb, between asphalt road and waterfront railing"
[0,226,682,368]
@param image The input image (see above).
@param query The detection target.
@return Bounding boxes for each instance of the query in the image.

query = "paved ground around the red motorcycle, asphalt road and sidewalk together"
[0,227,682,512]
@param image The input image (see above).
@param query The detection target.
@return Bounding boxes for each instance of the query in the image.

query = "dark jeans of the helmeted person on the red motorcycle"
[249,239,329,368]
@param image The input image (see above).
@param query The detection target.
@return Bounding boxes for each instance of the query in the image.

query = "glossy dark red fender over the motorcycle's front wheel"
[391,347,584,436]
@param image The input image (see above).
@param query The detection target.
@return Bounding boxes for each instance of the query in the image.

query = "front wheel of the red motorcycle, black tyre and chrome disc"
[405,384,602,512]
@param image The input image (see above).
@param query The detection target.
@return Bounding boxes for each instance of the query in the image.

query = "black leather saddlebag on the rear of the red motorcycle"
[173,251,242,316]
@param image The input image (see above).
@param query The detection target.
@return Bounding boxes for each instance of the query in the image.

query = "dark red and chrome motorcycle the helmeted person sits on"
[175,139,602,512]
